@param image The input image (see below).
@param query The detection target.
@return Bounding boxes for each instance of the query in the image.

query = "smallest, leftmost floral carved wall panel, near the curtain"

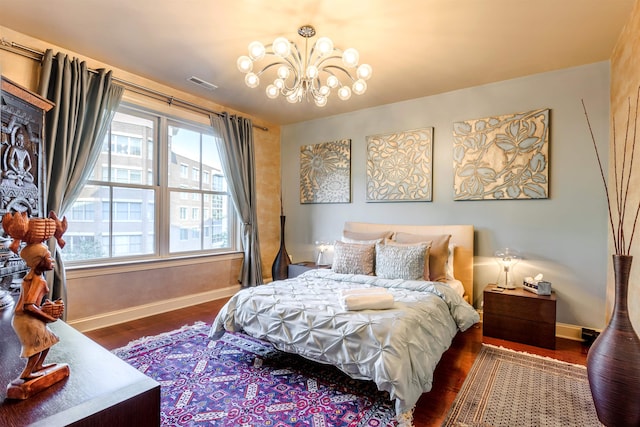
[300,139,351,203]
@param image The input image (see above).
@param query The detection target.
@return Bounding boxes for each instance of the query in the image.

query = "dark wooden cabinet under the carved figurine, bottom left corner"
[0,300,160,427]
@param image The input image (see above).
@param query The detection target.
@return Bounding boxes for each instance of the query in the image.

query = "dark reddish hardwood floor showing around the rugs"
[85,300,587,427]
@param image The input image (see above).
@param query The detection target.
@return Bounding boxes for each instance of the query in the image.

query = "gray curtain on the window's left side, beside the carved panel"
[38,49,124,310]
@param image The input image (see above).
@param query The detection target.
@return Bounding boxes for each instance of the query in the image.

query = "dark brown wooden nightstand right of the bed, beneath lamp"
[482,285,556,349]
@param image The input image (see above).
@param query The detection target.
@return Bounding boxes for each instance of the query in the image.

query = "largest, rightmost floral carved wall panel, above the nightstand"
[453,109,549,200]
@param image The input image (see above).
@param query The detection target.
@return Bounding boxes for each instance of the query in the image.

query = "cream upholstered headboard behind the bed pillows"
[344,221,474,303]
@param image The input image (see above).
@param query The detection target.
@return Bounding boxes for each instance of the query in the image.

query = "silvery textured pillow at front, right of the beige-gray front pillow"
[376,243,429,280]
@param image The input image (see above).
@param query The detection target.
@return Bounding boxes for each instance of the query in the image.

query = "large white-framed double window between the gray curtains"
[61,105,236,263]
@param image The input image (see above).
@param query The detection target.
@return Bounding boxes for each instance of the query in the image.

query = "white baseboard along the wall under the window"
[67,286,240,332]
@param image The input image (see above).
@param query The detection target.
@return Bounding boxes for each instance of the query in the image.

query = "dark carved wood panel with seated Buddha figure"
[0,77,53,280]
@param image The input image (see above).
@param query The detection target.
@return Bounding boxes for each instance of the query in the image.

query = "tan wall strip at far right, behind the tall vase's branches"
[607,1,640,331]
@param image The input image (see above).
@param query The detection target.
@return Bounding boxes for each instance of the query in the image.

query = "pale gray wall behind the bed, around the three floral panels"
[281,61,610,328]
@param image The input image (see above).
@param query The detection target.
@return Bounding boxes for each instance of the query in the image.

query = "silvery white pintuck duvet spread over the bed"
[209,269,480,415]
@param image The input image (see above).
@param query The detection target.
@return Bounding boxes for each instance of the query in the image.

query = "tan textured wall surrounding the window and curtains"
[0,26,280,322]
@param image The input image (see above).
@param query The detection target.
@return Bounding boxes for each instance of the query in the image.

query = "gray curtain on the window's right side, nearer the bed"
[211,113,262,288]
